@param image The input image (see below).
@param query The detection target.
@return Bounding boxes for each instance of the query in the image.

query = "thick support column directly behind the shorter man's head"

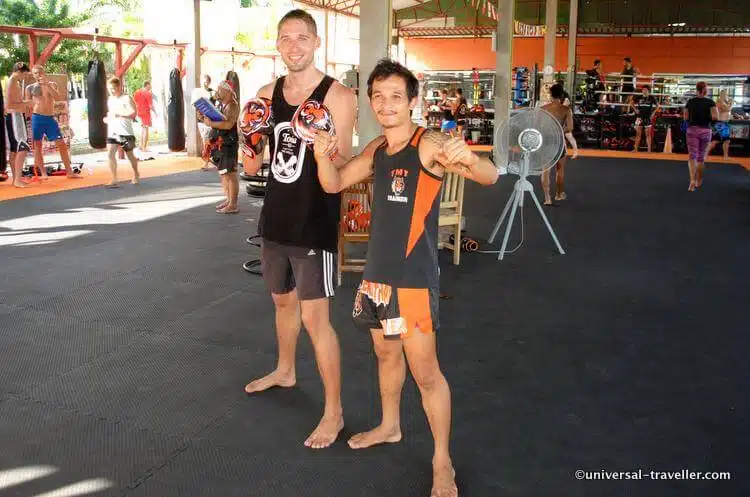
[357,0,393,151]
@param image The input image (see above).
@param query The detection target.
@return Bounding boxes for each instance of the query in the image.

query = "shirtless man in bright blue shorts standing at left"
[25,65,81,179]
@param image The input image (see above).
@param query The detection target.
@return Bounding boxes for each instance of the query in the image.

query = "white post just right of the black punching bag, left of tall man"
[183,0,202,157]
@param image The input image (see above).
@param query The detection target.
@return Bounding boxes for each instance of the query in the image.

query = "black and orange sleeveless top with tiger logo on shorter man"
[363,128,443,288]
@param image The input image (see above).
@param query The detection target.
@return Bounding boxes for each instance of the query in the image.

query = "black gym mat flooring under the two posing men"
[0,158,750,497]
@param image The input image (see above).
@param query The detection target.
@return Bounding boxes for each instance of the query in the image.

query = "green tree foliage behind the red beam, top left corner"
[0,0,114,75]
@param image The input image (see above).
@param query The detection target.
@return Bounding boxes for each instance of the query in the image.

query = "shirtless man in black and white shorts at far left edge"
[3,62,34,188]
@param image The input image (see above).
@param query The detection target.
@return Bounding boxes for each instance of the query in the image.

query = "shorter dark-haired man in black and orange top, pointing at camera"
[315,60,498,497]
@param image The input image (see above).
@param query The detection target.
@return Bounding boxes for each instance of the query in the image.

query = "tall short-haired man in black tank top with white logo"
[244,10,357,449]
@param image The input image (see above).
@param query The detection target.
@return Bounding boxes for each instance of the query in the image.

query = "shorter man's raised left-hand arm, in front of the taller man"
[314,131,385,193]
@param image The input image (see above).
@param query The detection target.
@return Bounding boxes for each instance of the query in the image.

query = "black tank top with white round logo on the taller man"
[259,76,341,252]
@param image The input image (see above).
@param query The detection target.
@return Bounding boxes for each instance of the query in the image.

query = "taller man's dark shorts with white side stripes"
[260,239,336,300]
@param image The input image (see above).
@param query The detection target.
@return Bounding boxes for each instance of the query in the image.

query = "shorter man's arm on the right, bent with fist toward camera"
[419,130,499,185]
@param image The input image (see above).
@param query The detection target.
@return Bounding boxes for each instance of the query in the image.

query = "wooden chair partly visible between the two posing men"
[336,180,372,286]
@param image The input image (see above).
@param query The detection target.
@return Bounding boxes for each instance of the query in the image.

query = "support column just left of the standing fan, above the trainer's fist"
[494,0,515,167]
